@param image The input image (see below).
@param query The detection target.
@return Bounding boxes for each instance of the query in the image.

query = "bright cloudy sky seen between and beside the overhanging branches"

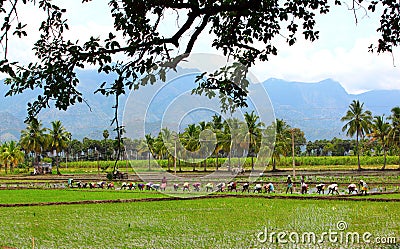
[3,0,400,93]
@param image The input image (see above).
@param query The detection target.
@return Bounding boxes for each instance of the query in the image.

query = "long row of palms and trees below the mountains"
[0,100,400,172]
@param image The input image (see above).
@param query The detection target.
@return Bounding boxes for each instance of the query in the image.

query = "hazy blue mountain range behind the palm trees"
[0,70,400,141]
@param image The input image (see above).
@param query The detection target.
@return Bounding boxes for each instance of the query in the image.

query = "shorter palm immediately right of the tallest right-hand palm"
[369,115,391,170]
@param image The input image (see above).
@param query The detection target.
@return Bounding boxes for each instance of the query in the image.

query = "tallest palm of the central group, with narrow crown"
[244,111,265,170]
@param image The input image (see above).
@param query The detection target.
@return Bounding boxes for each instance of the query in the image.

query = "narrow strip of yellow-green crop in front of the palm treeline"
[55,156,400,173]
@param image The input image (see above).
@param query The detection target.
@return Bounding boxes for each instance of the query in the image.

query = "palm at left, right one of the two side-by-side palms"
[49,120,71,175]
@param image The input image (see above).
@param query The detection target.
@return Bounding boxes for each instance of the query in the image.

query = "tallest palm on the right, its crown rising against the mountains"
[341,100,372,170]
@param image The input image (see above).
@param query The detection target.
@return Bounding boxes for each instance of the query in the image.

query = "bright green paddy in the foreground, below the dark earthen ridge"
[0,198,400,248]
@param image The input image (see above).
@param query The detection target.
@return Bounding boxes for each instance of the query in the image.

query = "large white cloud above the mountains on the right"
[252,5,400,93]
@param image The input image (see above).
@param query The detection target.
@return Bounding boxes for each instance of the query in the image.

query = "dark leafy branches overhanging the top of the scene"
[0,0,400,121]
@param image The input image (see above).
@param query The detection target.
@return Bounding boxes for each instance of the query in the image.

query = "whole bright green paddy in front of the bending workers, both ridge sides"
[0,189,400,248]
